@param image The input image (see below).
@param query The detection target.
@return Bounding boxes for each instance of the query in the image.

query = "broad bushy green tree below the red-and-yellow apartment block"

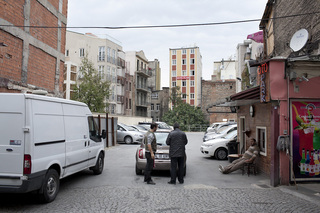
[163,87,208,131]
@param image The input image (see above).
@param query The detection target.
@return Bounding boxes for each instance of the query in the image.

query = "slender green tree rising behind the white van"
[72,56,110,112]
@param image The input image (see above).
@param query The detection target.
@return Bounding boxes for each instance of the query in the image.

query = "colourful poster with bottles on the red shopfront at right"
[291,100,320,181]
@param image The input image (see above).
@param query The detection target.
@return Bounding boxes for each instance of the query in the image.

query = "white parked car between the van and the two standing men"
[117,124,144,144]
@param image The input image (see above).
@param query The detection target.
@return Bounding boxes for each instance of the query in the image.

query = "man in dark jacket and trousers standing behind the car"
[166,123,188,184]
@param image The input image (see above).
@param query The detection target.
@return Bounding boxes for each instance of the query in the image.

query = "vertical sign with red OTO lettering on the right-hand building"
[257,63,270,103]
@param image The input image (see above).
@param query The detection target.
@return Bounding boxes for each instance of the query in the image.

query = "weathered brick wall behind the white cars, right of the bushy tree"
[201,80,237,123]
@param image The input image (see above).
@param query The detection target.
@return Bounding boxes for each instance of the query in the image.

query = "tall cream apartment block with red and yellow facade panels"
[169,46,202,108]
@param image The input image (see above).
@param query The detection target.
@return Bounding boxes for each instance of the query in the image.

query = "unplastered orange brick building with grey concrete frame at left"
[0,0,68,97]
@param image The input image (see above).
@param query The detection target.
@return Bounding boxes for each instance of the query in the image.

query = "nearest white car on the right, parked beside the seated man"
[200,130,237,160]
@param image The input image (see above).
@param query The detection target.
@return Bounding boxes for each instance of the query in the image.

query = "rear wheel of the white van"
[39,169,60,203]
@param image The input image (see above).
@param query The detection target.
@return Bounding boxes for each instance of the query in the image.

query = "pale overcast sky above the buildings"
[67,0,267,87]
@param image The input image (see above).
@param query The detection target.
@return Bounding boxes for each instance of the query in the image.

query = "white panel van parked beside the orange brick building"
[0,93,105,202]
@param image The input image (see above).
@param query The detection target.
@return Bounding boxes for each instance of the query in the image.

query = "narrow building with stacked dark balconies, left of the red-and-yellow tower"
[126,50,151,117]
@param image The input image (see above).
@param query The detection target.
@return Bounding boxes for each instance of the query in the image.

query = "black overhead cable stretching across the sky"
[0,12,320,30]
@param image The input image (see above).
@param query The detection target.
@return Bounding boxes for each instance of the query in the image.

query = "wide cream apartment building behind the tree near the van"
[64,31,131,115]
